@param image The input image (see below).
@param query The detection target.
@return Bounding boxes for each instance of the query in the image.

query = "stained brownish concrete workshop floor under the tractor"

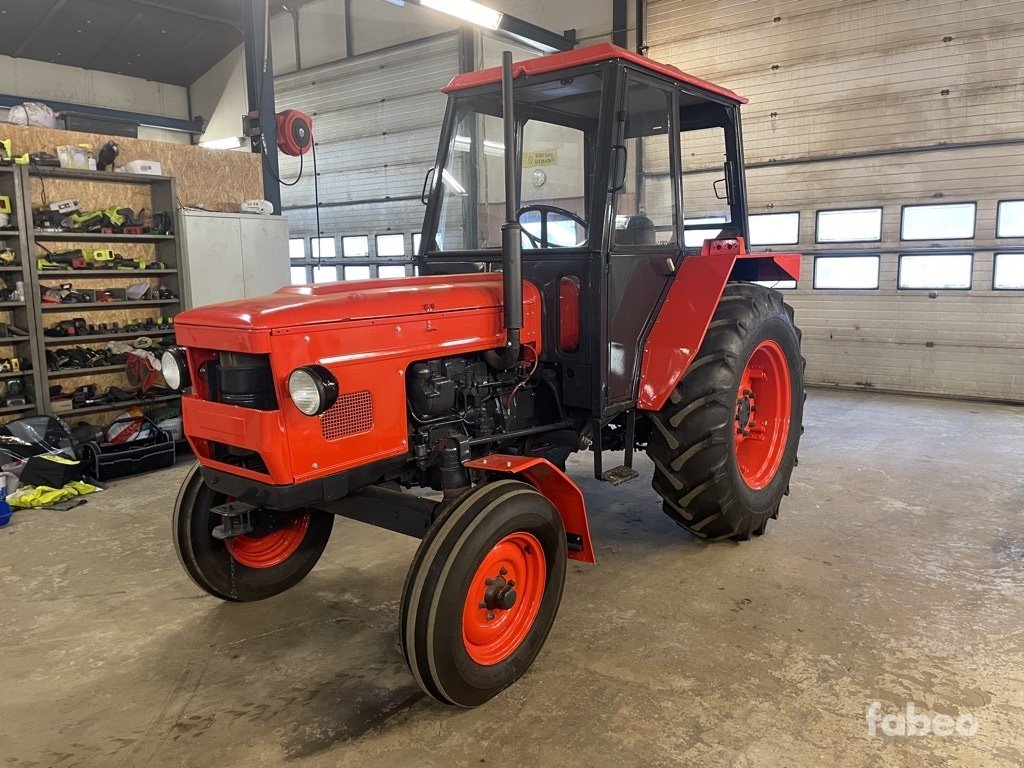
[0,391,1024,768]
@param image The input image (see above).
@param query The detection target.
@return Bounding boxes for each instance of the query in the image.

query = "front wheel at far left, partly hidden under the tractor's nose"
[174,464,334,602]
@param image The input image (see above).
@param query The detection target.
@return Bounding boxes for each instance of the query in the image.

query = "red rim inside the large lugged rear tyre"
[734,340,793,490]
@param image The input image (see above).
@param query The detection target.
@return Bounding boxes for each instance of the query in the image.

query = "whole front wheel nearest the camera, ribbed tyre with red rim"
[399,479,566,707]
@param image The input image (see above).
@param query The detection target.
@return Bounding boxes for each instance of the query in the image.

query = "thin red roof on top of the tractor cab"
[441,43,748,104]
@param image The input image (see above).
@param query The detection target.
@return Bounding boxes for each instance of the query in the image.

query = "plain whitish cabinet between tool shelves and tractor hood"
[179,210,291,307]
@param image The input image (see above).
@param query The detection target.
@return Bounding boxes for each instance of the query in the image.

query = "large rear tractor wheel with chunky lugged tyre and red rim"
[647,284,804,540]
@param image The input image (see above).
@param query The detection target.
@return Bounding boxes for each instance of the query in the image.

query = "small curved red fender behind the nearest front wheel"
[465,454,596,563]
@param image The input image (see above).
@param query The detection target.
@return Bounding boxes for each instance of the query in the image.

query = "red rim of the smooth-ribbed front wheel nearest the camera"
[462,531,548,667]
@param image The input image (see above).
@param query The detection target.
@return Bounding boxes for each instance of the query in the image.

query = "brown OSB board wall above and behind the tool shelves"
[0,123,263,204]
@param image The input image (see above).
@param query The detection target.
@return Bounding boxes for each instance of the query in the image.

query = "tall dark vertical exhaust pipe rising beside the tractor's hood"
[493,51,522,369]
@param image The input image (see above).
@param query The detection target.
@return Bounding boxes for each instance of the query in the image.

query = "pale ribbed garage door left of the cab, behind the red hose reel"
[274,34,459,276]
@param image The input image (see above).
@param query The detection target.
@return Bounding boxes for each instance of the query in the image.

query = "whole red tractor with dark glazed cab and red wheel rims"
[163,44,804,707]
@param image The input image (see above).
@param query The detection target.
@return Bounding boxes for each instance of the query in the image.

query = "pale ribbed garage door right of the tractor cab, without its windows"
[648,0,1024,400]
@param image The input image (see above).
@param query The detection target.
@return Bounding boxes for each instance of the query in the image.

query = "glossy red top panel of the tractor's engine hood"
[174,273,520,331]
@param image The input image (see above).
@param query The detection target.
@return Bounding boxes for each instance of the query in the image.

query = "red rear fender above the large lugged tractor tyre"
[637,238,800,411]
